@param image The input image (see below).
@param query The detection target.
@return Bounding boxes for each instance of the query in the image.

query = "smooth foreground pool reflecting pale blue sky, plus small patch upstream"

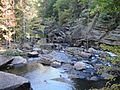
[4,50,105,90]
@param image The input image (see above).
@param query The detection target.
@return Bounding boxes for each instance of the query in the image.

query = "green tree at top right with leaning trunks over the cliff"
[79,0,120,47]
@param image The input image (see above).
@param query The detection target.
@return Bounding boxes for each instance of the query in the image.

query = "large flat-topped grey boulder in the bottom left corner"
[0,71,31,90]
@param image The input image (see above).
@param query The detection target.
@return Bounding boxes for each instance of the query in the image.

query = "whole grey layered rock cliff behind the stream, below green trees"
[45,18,120,46]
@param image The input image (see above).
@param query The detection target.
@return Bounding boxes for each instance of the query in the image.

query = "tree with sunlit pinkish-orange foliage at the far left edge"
[0,0,17,47]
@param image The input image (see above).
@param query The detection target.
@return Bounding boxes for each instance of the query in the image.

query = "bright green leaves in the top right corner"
[82,0,120,13]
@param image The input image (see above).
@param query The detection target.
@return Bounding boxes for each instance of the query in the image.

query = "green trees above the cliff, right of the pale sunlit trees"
[39,0,120,24]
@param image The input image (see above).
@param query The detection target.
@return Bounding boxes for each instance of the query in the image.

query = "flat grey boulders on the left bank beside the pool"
[0,55,32,90]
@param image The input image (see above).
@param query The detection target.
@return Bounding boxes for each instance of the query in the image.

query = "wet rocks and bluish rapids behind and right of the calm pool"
[24,44,119,81]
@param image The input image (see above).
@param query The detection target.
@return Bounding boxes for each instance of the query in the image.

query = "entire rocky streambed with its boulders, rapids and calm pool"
[1,44,119,90]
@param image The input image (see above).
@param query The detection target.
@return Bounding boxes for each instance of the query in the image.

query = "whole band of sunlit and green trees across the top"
[0,0,120,47]
